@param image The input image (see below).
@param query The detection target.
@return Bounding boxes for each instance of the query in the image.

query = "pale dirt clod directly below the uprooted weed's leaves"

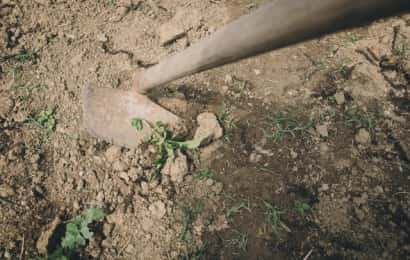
[161,152,188,183]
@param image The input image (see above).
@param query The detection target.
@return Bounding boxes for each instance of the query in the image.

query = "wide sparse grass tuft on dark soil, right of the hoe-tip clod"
[265,111,313,141]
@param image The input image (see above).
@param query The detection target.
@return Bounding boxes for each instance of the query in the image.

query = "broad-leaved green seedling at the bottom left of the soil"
[48,208,105,260]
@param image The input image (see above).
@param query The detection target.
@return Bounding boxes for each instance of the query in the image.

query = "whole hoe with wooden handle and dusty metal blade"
[82,0,410,148]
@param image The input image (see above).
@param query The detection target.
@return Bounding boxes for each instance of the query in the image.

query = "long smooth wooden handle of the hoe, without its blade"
[137,0,410,93]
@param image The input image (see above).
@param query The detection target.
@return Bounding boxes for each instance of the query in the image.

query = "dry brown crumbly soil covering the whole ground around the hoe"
[0,0,410,259]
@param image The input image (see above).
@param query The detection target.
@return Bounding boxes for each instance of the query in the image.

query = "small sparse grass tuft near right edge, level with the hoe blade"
[345,108,377,132]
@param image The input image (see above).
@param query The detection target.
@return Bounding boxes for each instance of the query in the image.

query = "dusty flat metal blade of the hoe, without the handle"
[82,87,182,148]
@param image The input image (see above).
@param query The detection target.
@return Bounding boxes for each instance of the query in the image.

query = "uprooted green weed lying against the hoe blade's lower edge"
[131,118,203,176]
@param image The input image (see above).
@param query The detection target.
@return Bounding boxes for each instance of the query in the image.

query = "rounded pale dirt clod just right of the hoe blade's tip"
[195,112,223,144]
